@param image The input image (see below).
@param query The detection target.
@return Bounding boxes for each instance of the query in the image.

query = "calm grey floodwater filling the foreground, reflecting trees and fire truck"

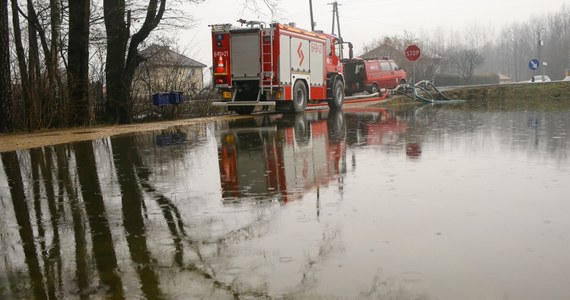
[0,104,570,300]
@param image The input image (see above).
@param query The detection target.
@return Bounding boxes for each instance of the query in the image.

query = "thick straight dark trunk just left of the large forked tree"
[67,0,90,126]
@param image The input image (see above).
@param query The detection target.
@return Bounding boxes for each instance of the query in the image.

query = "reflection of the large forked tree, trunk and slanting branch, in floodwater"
[112,136,276,299]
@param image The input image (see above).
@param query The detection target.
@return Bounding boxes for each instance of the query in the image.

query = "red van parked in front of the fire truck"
[343,58,407,95]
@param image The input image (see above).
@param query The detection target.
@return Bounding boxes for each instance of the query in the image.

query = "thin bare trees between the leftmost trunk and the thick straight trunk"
[11,0,67,130]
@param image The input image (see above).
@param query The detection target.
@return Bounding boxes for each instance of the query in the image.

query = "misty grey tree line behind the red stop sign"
[363,5,570,84]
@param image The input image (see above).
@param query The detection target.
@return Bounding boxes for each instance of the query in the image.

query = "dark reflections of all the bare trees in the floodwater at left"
[0,127,346,299]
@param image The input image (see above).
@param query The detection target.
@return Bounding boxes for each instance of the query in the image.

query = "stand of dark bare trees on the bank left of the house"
[0,0,211,132]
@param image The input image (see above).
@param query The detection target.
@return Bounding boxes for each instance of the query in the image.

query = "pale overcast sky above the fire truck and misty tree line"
[179,0,569,65]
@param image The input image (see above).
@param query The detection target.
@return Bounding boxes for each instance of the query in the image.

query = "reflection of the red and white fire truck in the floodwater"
[218,111,346,202]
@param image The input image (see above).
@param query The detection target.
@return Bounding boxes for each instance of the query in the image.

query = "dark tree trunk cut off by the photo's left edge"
[0,0,13,132]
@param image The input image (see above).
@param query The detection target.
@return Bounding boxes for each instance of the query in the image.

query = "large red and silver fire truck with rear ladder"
[210,20,352,114]
